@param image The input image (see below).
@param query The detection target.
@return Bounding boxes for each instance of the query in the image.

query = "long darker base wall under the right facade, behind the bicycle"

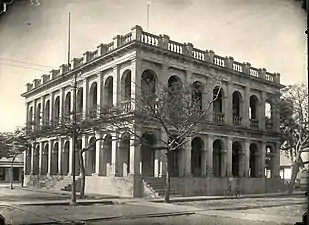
[171,177,268,196]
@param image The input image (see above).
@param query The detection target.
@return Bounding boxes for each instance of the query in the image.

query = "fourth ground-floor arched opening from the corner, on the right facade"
[213,139,224,177]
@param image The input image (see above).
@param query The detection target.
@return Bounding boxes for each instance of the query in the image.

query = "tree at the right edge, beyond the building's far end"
[280,84,309,195]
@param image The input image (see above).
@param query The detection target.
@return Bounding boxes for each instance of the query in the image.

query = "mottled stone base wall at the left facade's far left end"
[24,175,63,188]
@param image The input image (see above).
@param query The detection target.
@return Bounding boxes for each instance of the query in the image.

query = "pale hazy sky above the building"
[0,0,307,132]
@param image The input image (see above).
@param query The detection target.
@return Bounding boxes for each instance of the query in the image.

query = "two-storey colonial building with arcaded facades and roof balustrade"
[22,26,282,196]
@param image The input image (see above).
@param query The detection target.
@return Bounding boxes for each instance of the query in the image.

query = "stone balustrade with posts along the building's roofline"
[27,26,280,92]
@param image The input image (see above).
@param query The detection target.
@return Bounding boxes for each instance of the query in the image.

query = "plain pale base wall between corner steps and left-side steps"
[85,176,136,197]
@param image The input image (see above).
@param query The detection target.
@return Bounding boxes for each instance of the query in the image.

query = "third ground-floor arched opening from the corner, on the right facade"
[191,137,204,177]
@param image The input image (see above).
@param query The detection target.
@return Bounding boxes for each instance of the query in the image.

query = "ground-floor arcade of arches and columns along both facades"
[25,132,280,178]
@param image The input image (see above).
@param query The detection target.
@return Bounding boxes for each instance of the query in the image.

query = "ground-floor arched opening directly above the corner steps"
[141,132,157,177]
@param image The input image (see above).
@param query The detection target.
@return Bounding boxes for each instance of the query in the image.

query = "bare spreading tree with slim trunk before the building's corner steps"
[97,79,222,202]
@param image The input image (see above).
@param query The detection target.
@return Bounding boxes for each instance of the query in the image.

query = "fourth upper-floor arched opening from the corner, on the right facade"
[213,86,224,123]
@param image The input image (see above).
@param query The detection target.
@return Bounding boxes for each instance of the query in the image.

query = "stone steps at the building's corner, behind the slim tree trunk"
[143,177,181,198]
